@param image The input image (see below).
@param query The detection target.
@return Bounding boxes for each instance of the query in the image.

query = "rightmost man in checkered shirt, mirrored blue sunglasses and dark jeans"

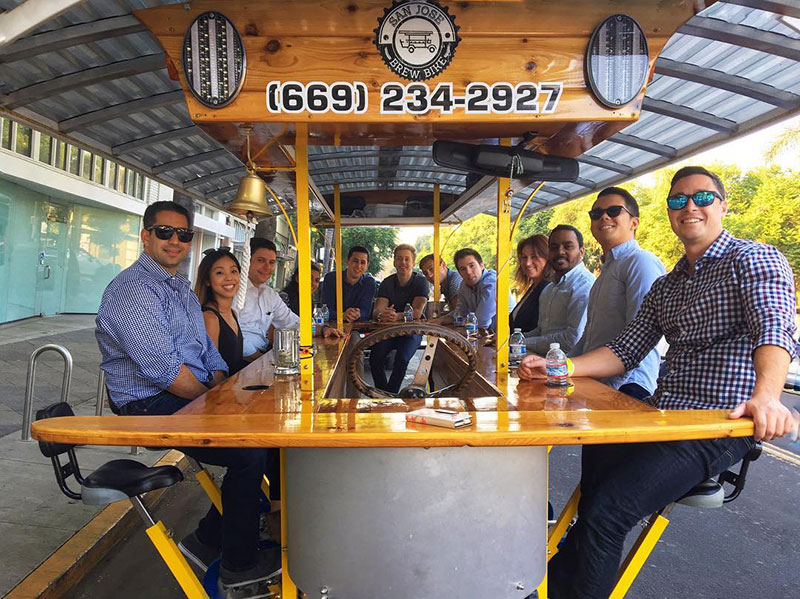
[519,167,796,599]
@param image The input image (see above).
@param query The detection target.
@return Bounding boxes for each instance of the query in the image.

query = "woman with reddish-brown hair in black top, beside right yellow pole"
[509,234,552,333]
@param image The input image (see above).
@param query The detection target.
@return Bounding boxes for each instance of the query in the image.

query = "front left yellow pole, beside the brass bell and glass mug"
[295,123,314,391]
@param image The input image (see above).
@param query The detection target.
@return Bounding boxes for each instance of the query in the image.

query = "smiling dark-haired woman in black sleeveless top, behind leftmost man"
[194,248,247,375]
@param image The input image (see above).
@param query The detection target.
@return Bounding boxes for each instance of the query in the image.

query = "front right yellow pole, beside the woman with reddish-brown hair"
[495,139,511,375]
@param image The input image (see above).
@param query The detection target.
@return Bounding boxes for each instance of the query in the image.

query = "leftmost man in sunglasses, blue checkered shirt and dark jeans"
[95,202,280,587]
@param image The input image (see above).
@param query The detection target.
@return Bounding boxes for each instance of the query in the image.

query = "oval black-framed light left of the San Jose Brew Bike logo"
[183,11,247,108]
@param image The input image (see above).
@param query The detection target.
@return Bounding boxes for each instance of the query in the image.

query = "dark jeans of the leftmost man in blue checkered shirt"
[118,391,280,570]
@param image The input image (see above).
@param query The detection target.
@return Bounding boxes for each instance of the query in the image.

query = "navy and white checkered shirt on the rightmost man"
[607,231,796,409]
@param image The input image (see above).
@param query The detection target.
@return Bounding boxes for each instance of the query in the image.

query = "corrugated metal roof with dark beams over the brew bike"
[0,0,800,223]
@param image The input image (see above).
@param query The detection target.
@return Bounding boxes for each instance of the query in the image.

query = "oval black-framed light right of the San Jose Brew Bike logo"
[586,15,650,108]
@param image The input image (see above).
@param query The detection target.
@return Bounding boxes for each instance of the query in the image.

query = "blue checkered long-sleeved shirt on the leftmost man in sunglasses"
[95,254,228,406]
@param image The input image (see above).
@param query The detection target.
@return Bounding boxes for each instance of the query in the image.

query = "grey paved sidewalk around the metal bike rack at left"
[0,315,162,596]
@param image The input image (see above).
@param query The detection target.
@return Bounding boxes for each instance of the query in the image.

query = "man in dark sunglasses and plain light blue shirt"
[571,187,667,399]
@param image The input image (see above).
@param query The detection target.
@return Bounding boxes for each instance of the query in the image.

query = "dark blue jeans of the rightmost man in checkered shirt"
[548,437,753,599]
